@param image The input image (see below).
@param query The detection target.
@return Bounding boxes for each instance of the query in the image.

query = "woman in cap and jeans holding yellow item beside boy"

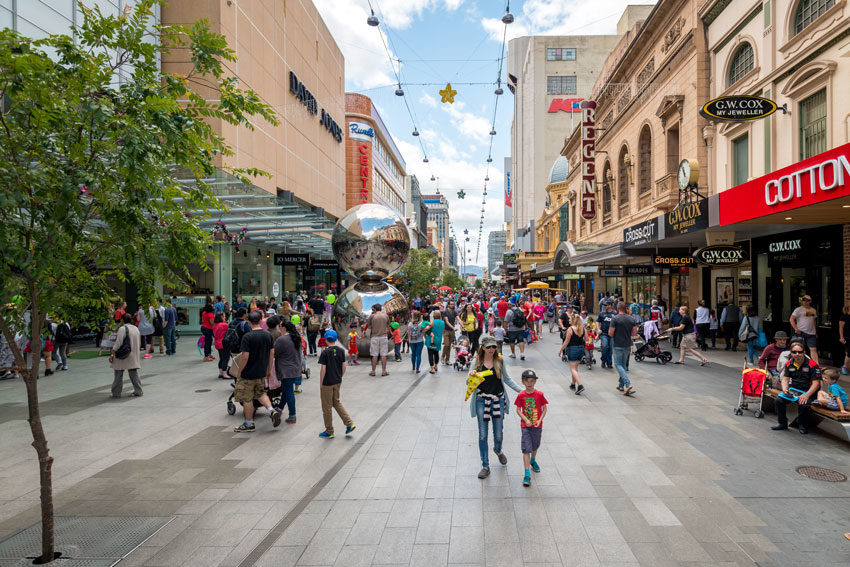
[469,337,521,479]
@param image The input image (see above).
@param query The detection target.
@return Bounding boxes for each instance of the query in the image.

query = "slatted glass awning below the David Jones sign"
[177,169,335,258]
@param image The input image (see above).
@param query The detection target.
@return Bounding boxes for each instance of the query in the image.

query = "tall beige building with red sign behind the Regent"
[507,6,650,246]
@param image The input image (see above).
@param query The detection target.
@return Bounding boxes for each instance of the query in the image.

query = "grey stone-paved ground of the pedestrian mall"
[0,333,850,567]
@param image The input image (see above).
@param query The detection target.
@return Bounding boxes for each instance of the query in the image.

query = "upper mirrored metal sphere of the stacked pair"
[331,203,410,282]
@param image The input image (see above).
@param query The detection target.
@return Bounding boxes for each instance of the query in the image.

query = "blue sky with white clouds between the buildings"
[313,0,651,266]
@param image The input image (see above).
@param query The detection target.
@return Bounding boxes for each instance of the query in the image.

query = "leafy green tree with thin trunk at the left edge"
[0,0,277,560]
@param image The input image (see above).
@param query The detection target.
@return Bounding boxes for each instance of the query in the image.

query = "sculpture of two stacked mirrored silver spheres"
[331,203,410,356]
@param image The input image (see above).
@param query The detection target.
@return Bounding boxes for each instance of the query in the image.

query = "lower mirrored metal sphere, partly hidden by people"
[332,280,410,357]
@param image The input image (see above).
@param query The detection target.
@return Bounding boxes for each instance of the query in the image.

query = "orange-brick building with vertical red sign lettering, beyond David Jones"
[345,93,407,217]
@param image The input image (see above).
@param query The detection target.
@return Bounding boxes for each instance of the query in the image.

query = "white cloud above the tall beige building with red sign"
[481,0,654,41]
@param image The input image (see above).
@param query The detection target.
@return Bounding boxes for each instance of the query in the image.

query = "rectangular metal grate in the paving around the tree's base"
[0,516,173,567]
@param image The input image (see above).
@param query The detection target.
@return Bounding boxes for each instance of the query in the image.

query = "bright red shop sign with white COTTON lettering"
[720,144,850,225]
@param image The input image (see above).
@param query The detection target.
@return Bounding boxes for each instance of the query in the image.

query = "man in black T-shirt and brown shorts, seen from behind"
[233,311,280,433]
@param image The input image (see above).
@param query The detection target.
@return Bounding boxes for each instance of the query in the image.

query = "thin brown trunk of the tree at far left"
[0,296,54,563]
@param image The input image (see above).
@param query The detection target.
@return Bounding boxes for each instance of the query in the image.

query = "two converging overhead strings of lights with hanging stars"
[366,0,514,276]
